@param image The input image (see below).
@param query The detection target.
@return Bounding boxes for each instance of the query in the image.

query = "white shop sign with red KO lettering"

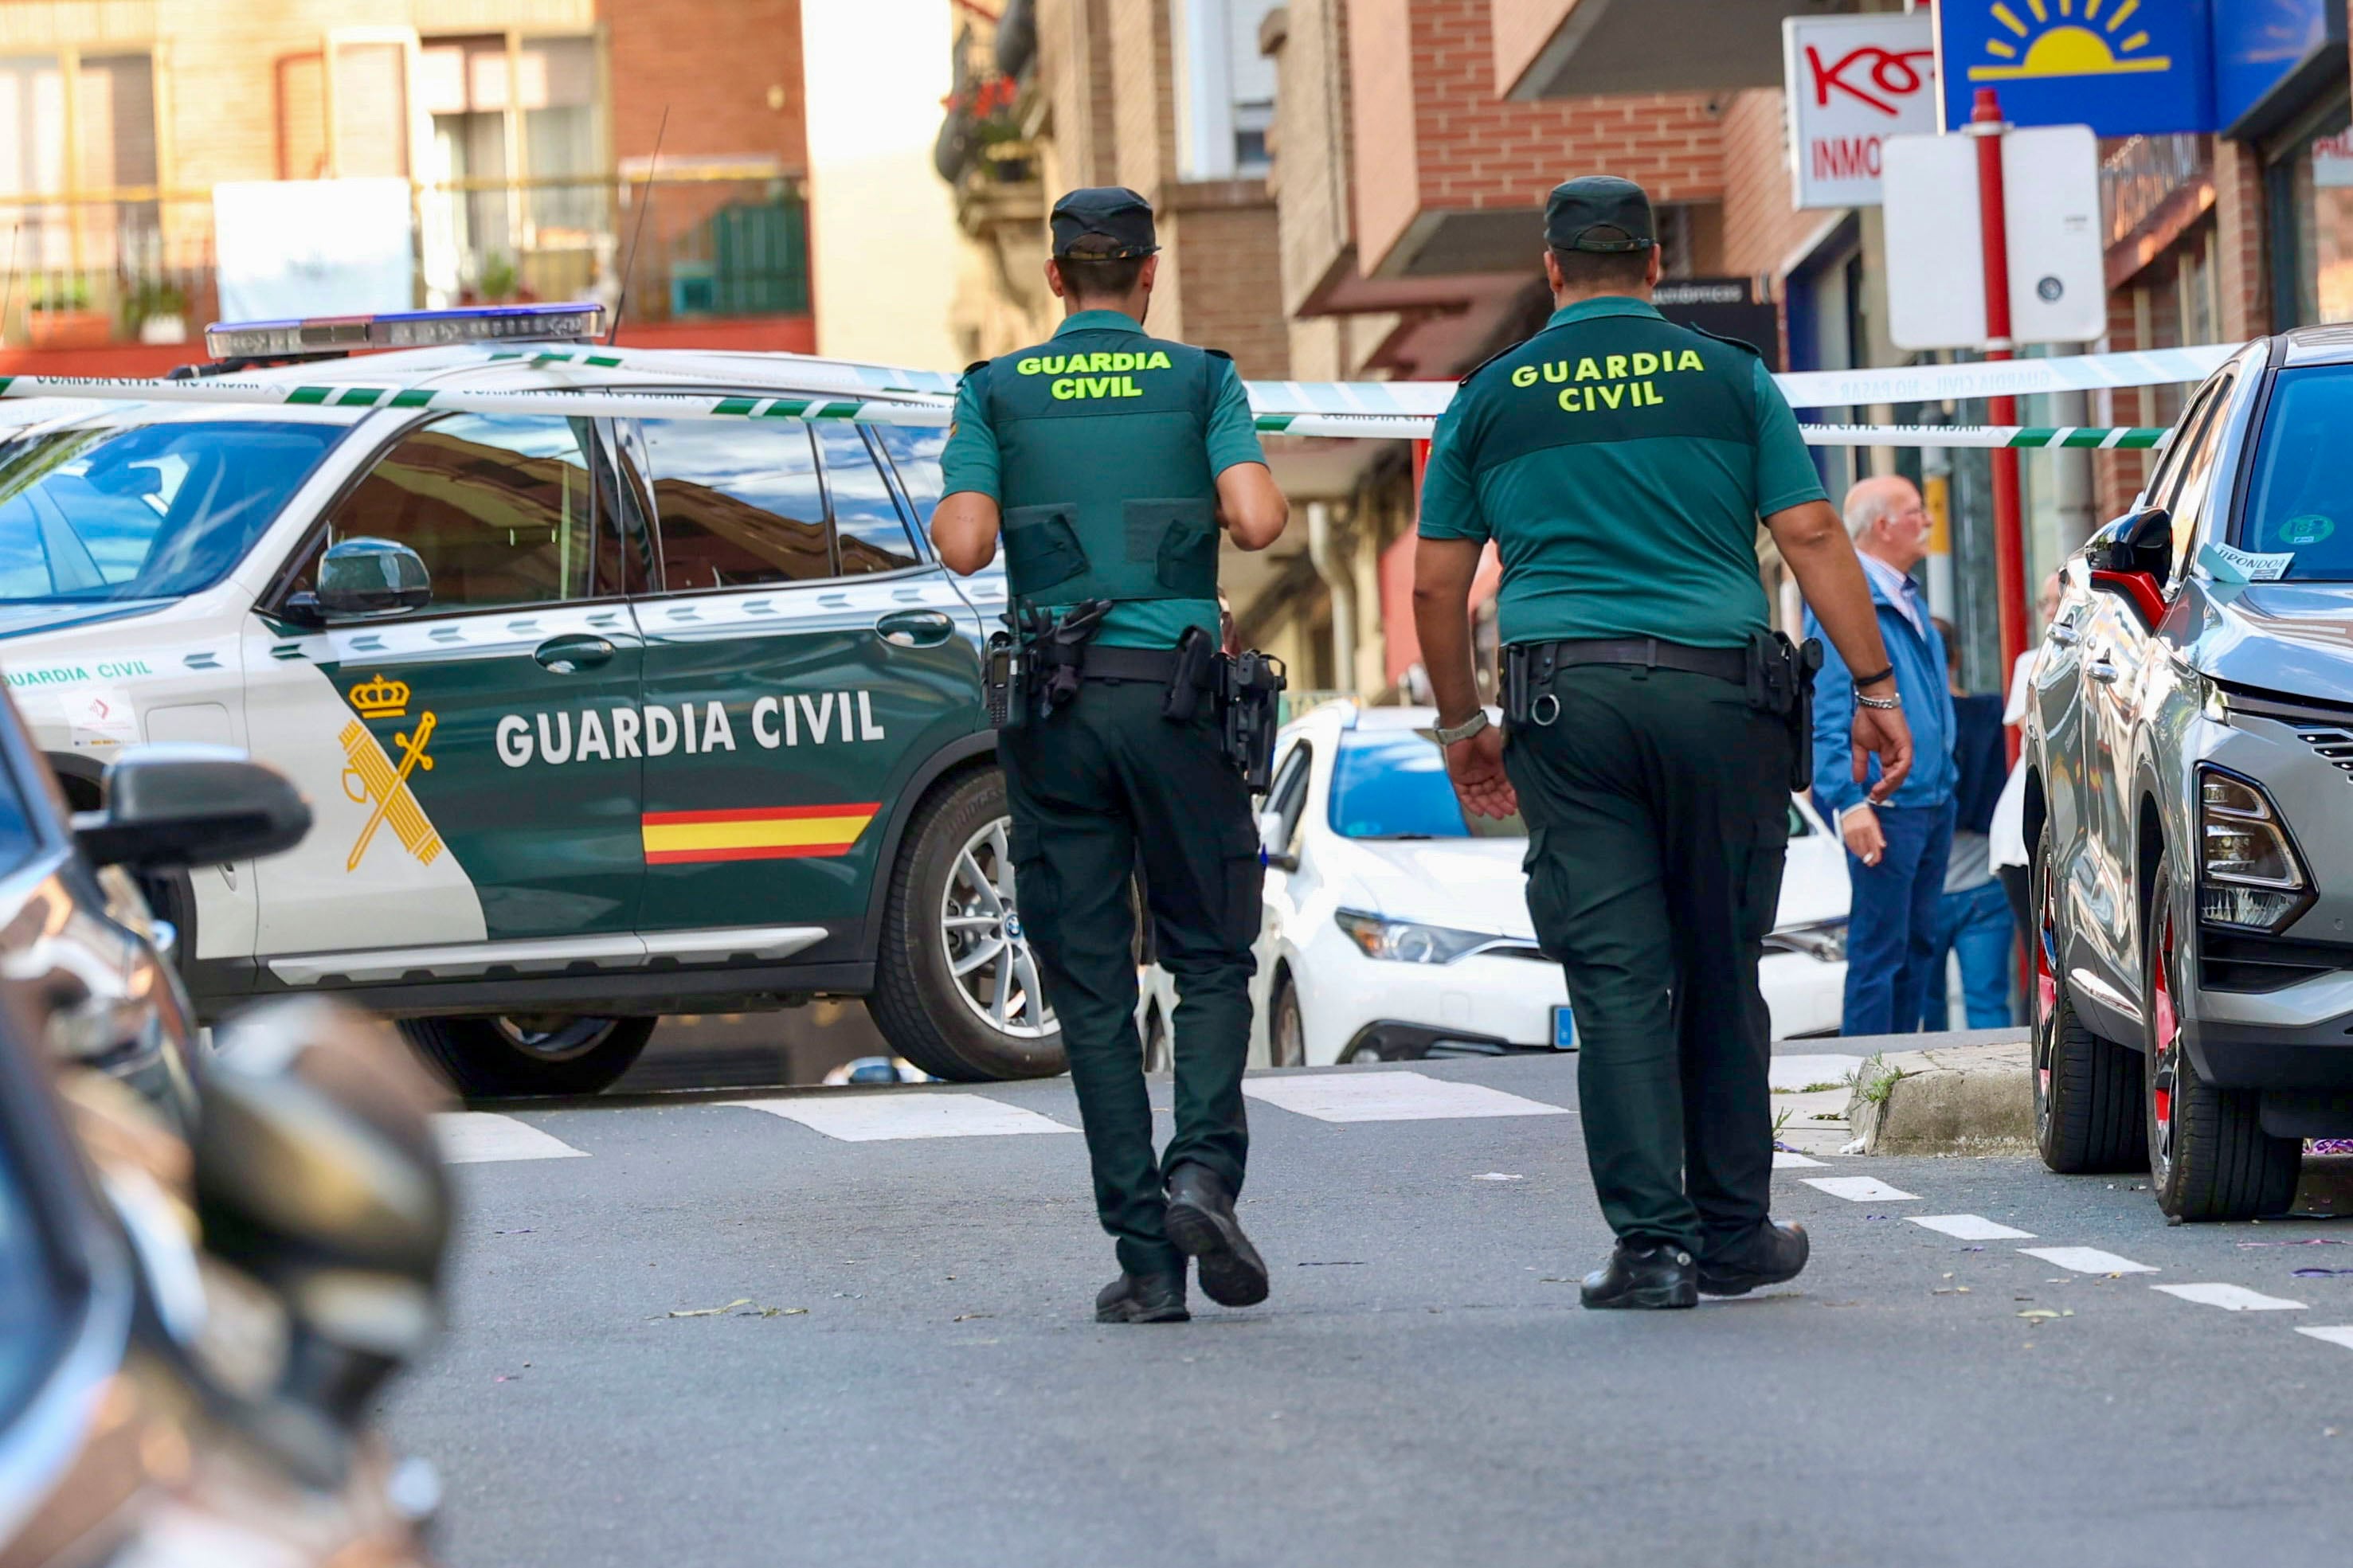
[1781,12,1936,209]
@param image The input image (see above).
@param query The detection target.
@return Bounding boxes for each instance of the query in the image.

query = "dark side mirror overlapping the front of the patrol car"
[73,745,311,870]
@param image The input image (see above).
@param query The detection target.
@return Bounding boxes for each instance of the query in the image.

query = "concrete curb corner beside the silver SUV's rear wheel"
[1847,1039,2035,1154]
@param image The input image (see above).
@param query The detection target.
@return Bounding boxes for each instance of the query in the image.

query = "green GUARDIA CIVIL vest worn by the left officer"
[986,331,1223,604]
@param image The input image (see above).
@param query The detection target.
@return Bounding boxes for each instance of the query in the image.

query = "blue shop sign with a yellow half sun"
[1936,0,2214,136]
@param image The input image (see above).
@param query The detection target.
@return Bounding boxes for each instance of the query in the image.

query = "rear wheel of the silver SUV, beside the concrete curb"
[2028,823,2148,1175]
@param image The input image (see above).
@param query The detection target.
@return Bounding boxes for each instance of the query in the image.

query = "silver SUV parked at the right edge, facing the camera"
[2026,327,2353,1220]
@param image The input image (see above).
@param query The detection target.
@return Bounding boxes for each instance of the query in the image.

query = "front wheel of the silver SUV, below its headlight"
[2141,856,2304,1220]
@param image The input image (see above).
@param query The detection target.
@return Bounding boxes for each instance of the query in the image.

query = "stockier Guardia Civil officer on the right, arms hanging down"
[1414,176,1911,1307]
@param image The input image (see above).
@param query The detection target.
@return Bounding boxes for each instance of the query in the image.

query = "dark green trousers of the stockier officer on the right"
[1504,665,1791,1257]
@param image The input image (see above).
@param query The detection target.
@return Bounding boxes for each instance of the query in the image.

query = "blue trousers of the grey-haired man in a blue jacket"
[1840,802,1953,1034]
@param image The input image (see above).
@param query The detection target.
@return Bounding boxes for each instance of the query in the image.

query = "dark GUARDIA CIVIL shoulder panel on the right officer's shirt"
[1463,315,1758,472]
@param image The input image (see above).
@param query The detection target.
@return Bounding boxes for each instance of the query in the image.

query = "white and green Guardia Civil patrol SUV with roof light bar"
[0,306,1061,1096]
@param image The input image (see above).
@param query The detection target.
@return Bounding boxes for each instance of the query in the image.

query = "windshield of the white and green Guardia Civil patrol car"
[0,418,346,604]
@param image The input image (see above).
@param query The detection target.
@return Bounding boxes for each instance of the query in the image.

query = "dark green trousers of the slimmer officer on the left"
[997,682,1263,1274]
